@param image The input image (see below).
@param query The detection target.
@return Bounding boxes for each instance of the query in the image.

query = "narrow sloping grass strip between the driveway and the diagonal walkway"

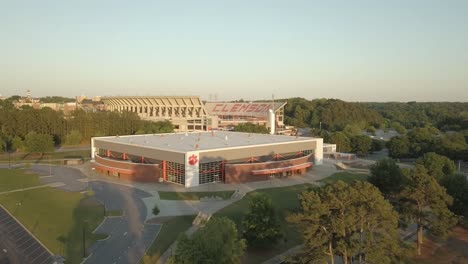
[140,215,196,264]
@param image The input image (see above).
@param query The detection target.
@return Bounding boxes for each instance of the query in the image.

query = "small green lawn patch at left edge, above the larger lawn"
[0,169,40,192]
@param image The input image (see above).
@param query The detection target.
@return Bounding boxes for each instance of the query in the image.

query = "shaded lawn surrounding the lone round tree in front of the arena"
[215,184,315,263]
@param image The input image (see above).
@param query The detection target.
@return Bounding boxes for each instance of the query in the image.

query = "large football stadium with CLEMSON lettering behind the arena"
[101,96,286,133]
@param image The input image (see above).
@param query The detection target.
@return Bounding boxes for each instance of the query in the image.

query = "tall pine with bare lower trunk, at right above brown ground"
[400,164,456,255]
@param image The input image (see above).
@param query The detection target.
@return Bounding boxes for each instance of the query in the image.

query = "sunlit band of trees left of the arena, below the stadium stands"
[0,101,174,153]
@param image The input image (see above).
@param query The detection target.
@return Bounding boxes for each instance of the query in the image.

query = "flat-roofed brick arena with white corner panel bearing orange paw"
[91,131,323,187]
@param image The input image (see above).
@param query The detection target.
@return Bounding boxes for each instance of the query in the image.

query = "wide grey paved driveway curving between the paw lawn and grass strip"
[85,181,161,264]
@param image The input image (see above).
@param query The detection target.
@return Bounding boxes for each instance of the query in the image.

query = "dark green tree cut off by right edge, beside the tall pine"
[441,174,468,217]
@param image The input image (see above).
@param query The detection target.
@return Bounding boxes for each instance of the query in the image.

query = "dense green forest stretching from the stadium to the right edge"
[285,98,468,161]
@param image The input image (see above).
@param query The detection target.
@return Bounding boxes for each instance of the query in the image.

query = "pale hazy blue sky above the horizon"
[0,0,468,101]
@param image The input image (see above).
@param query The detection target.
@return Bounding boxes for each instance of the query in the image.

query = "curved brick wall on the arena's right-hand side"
[224,154,313,183]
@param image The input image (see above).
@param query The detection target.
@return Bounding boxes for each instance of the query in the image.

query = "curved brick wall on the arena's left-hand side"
[94,155,161,182]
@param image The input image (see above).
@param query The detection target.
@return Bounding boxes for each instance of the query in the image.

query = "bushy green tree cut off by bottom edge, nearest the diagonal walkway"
[170,217,246,264]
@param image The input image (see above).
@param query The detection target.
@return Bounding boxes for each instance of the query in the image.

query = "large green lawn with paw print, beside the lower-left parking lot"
[0,187,105,263]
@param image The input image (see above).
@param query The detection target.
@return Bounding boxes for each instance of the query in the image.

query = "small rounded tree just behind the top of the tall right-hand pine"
[416,152,455,182]
